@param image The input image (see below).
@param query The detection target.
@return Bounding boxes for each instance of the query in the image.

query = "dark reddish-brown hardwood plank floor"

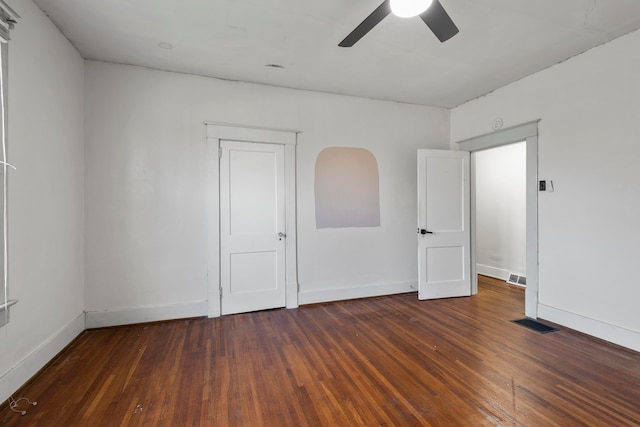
[0,278,640,426]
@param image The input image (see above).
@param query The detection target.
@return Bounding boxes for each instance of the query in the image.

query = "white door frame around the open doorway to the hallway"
[456,120,540,319]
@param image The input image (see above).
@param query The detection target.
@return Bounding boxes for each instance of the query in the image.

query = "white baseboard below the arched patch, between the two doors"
[298,282,418,305]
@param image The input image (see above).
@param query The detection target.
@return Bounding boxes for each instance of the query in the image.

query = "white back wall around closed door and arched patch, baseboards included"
[85,61,449,324]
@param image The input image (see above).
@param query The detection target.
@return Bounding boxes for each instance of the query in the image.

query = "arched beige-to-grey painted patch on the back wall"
[315,147,380,228]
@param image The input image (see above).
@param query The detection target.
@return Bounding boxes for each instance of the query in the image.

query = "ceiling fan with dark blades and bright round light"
[338,0,458,47]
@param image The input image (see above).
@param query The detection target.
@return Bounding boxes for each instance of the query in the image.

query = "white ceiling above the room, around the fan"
[34,0,640,108]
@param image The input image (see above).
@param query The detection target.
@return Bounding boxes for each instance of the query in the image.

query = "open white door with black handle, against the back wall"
[418,150,471,299]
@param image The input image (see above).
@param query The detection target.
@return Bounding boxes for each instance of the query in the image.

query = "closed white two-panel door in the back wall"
[220,140,286,314]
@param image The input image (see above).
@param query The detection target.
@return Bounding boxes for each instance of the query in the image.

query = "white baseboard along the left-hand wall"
[0,313,85,402]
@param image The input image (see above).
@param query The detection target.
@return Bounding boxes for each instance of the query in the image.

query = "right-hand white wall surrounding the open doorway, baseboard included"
[451,28,640,350]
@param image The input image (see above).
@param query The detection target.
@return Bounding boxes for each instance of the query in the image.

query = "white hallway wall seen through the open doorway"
[472,142,527,280]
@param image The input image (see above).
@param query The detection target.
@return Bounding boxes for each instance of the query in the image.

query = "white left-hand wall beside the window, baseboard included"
[0,1,84,401]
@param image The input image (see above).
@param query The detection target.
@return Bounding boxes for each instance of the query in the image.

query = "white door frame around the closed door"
[204,122,300,317]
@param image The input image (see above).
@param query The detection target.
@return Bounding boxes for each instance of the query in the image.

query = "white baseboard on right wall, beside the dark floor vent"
[538,304,640,351]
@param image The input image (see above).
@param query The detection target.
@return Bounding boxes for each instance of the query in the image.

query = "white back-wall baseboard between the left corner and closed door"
[86,301,209,329]
